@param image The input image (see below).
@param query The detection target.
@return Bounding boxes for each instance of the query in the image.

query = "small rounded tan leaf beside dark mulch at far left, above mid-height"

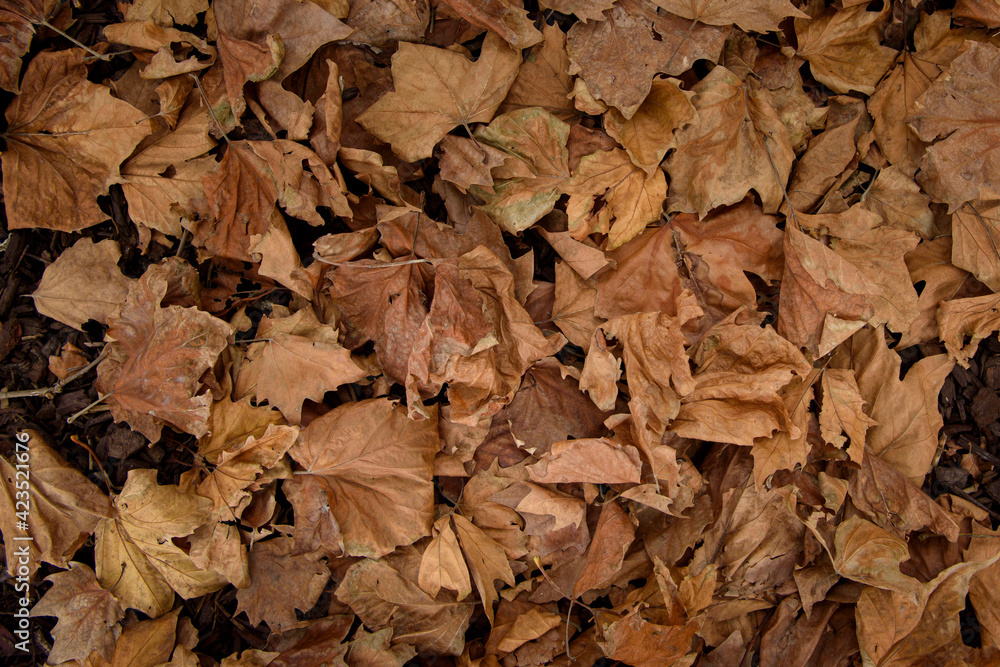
[31,239,132,331]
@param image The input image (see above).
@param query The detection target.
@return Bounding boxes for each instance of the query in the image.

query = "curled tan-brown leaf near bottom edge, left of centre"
[336,550,473,655]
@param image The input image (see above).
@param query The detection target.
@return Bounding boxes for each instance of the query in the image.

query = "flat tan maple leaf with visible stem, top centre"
[357,33,521,162]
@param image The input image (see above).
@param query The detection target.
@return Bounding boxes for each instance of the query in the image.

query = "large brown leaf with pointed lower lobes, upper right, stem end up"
[666,66,794,218]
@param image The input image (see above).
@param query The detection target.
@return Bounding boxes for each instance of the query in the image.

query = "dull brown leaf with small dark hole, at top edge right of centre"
[566,0,726,119]
